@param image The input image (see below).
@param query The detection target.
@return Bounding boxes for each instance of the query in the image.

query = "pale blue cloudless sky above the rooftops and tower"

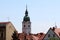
[0,0,60,33]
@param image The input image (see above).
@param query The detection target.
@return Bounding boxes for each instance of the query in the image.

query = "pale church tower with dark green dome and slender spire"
[22,7,31,35]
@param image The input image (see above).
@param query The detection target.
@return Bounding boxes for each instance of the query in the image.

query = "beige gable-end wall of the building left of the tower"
[6,23,16,40]
